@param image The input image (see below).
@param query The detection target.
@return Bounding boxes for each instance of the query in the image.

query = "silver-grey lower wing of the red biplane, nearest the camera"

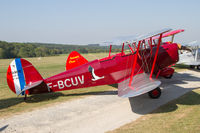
[118,73,161,97]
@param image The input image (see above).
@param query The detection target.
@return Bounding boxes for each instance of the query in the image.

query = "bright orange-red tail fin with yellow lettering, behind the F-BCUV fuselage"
[66,51,88,70]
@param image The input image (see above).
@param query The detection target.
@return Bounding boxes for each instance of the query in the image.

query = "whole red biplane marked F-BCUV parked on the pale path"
[7,29,184,98]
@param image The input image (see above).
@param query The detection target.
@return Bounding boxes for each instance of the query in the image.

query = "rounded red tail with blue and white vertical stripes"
[7,58,43,95]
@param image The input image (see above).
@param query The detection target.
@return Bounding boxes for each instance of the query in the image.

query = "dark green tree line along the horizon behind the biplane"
[0,41,121,59]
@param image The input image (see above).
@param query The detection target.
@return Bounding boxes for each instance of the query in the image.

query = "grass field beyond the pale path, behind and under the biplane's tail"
[0,53,115,117]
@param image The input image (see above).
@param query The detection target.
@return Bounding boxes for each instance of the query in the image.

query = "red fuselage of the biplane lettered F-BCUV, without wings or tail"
[26,43,178,94]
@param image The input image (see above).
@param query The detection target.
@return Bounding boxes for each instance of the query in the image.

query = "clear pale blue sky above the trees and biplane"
[0,0,200,44]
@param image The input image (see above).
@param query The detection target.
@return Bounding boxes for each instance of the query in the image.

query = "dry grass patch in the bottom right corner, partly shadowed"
[108,89,200,133]
